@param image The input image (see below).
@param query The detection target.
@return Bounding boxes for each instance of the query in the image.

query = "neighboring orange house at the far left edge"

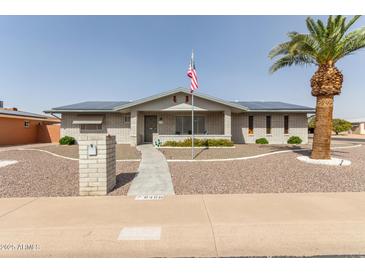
[0,101,60,146]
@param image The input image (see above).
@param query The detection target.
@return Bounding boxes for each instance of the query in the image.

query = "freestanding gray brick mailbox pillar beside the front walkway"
[78,135,116,196]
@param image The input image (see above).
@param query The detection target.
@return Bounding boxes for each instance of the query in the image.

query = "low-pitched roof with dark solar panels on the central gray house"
[44,87,314,113]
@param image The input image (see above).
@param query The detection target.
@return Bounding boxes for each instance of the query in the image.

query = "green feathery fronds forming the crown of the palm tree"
[269,15,365,73]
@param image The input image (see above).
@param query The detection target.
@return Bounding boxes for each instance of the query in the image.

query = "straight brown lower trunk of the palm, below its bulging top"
[311,95,333,159]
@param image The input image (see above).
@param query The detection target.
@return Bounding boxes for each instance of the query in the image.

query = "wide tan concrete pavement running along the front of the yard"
[0,193,365,257]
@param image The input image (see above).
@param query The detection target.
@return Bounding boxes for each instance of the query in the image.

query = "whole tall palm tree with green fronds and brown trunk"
[269,15,365,159]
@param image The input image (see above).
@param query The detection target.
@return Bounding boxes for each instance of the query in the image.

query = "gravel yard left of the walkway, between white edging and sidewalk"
[0,151,139,198]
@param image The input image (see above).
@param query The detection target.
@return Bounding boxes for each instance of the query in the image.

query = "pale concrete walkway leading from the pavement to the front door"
[128,144,175,196]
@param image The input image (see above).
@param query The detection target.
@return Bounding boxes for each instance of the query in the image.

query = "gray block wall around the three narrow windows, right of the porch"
[232,112,308,144]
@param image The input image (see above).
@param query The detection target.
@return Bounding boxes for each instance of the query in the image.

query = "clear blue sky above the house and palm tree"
[0,16,365,118]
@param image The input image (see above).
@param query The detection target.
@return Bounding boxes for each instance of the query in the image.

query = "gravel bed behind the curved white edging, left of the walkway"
[37,144,141,160]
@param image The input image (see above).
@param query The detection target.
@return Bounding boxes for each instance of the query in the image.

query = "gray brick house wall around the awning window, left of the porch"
[61,113,131,144]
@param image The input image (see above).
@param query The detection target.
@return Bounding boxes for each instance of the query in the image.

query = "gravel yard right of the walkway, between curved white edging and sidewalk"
[169,146,365,194]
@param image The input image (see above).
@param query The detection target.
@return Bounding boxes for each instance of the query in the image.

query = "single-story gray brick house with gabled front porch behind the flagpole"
[45,88,314,145]
